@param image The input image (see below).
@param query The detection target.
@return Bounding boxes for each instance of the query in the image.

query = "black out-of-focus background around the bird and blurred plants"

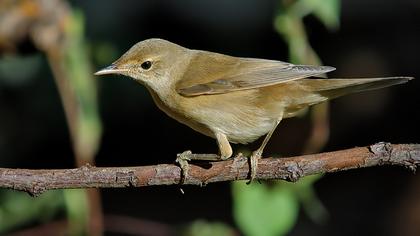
[0,0,420,235]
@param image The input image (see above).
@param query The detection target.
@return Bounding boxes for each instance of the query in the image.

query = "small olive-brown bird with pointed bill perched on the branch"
[95,38,412,181]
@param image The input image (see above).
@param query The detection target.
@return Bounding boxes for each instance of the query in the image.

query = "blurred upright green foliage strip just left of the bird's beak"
[63,11,102,162]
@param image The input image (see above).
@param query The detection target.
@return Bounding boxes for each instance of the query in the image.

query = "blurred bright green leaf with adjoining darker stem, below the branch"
[232,175,328,236]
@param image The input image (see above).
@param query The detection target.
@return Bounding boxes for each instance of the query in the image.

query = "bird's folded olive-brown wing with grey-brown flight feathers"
[176,51,335,96]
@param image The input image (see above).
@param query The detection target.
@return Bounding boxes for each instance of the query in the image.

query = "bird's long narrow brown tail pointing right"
[305,77,414,99]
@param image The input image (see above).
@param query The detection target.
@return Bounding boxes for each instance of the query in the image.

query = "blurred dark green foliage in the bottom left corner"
[0,190,64,234]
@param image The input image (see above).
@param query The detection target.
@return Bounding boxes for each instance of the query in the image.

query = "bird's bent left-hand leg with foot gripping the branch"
[176,132,233,183]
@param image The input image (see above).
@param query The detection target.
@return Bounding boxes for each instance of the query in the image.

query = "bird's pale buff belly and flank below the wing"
[148,85,312,144]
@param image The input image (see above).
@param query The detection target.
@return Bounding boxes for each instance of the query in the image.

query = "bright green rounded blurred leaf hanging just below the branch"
[232,181,299,236]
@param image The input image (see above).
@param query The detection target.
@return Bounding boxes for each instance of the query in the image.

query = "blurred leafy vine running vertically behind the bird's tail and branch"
[232,0,340,236]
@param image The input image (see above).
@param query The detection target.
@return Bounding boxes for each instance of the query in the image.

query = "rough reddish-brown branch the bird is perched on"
[0,142,420,196]
